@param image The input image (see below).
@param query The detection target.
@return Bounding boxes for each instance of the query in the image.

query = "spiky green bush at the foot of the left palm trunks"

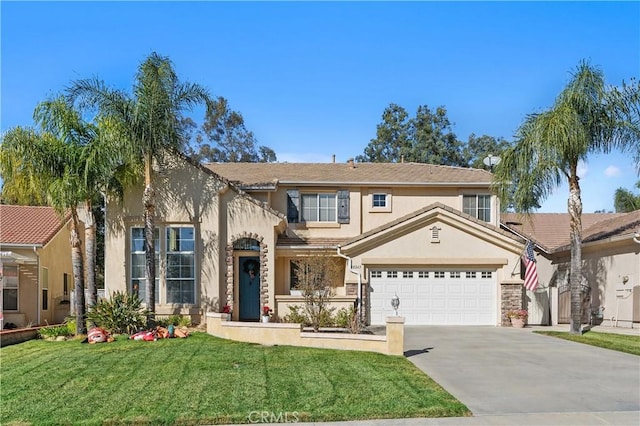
[87,291,150,334]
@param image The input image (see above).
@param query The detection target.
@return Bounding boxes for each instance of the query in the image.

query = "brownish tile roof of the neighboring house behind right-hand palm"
[500,213,625,252]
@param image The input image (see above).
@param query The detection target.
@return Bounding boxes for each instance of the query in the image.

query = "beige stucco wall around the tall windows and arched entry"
[105,158,281,322]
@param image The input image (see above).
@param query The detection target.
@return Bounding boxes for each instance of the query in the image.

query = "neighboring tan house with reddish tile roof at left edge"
[0,205,73,327]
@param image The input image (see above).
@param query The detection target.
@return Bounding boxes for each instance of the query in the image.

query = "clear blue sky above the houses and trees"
[0,1,640,212]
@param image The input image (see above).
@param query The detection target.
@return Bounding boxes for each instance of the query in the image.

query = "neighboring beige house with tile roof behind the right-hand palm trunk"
[502,210,640,327]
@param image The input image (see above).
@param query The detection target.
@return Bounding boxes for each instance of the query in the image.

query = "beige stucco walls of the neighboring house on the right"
[537,237,640,327]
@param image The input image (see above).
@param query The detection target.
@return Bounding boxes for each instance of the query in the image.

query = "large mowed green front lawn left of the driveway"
[0,333,471,425]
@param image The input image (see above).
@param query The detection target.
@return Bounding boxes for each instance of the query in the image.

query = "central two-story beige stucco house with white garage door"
[105,155,523,325]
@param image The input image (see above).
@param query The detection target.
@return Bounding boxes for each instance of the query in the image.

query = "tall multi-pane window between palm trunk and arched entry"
[166,226,196,304]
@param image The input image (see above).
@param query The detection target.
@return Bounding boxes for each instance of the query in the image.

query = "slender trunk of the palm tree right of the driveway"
[567,170,582,334]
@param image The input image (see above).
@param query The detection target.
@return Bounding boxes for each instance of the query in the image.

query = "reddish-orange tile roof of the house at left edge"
[0,204,67,245]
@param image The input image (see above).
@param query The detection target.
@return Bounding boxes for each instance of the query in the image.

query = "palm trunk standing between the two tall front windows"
[142,155,156,326]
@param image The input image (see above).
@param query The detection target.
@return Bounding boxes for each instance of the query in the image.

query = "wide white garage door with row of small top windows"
[369,269,497,325]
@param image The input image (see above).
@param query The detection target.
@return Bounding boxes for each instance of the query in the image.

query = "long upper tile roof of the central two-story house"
[204,163,492,186]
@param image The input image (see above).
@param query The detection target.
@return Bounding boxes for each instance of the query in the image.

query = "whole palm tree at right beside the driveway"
[494,61,640,334]
